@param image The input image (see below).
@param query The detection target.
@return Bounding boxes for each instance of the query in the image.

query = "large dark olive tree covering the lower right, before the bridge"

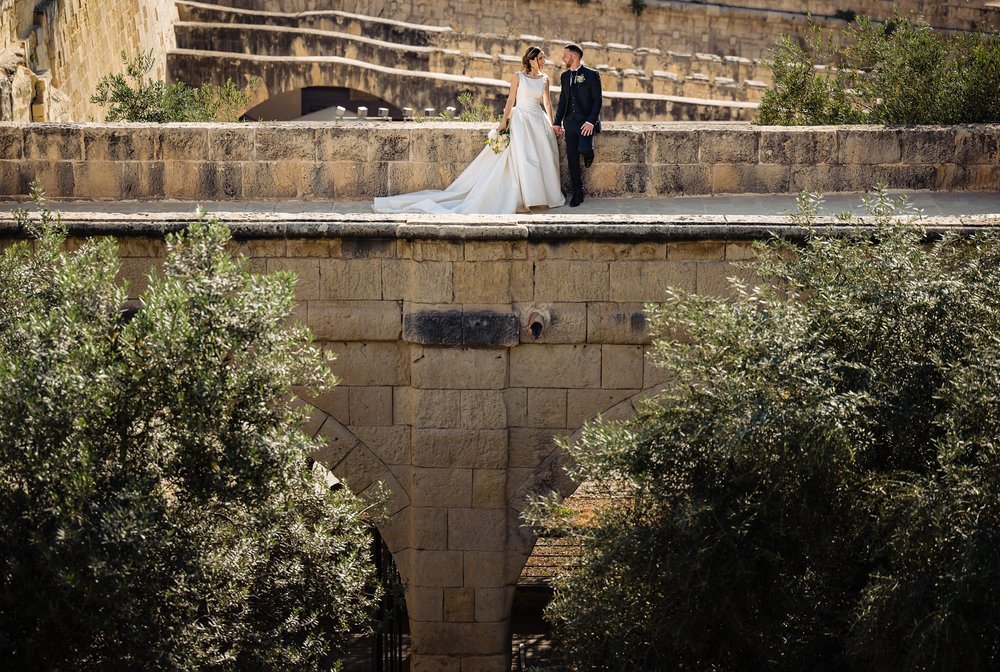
[530,185,1000,672]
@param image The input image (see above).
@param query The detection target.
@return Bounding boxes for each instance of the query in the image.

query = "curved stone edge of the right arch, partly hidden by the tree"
[507,385,663,585]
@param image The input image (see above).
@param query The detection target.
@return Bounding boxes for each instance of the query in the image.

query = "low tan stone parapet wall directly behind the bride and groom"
[0,122,1000,201]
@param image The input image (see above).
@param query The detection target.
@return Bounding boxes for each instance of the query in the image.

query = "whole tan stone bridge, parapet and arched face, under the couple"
[0,124,1000,672]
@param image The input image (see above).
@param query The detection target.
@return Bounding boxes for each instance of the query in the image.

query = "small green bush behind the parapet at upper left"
[90,51,259,123]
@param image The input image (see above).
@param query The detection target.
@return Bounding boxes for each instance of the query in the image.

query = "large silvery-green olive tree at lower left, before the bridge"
[0,186,377,670]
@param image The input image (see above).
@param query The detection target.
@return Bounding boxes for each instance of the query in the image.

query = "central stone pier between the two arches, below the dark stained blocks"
[394,345,514,672]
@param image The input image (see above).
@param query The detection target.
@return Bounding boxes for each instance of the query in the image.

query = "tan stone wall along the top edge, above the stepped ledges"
[207,0,1000,58]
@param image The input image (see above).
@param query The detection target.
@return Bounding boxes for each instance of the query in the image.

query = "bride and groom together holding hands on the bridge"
[374,44,601,214]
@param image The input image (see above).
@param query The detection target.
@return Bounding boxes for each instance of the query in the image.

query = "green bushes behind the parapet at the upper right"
[757,17,1000,125]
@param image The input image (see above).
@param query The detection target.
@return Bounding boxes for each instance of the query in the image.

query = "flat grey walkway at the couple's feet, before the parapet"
[0,192,1000,218]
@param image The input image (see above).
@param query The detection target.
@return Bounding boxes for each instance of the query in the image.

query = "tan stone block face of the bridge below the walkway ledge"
[0,212,780,672]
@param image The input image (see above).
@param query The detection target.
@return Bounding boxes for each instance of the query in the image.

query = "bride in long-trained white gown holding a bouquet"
[373,47,565,214]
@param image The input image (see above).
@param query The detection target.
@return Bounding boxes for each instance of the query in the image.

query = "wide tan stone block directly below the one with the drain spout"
[510,344,601,387]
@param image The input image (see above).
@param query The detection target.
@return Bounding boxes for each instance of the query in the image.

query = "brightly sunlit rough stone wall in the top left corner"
[2,0,177,121]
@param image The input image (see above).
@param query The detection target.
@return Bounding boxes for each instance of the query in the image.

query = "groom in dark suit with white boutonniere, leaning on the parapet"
[552,44,601,208]
